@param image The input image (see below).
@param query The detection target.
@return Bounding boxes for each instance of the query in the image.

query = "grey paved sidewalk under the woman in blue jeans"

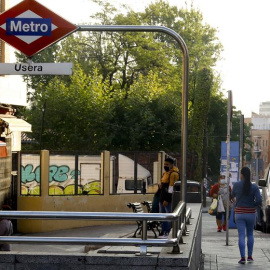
[201,198,270,270]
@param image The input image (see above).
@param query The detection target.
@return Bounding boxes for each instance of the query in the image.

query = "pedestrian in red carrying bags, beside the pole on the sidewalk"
[210,175,232,232]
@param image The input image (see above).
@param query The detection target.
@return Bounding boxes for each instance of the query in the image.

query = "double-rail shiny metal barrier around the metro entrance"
[0,202,191,255]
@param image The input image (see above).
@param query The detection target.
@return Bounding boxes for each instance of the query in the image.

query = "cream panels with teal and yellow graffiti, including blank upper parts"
[21,155,102,196]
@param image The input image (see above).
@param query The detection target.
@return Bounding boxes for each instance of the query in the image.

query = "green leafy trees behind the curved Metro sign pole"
[17,0,246,180]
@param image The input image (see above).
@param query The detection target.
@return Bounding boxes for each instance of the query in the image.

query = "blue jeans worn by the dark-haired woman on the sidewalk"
[235,214,255,257]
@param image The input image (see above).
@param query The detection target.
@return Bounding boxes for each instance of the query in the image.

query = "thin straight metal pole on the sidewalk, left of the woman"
[226,90,232,246]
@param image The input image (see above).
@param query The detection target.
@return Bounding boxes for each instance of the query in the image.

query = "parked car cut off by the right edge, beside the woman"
[259,165,270,233]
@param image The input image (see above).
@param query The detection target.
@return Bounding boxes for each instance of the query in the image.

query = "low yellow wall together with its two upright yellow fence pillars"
[18,150,156,233]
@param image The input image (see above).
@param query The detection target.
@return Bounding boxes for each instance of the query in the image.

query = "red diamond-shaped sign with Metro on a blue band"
[0,0,77,57]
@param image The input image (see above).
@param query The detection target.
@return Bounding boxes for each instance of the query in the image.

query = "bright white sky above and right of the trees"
[10,0,270,117]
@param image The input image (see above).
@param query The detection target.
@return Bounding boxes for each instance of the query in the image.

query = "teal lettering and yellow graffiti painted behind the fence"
[21,164,101,196]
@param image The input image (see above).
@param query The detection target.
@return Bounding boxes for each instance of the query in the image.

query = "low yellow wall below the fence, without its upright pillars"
[18,194,153,233]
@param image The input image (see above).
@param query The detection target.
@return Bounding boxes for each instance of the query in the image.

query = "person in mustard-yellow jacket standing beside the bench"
[159,158,179,238]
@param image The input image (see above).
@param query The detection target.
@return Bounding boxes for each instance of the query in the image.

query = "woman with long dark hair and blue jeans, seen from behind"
[232,167,262,264]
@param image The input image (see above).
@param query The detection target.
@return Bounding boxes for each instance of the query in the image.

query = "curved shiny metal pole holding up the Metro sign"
[76,25,189,206]
